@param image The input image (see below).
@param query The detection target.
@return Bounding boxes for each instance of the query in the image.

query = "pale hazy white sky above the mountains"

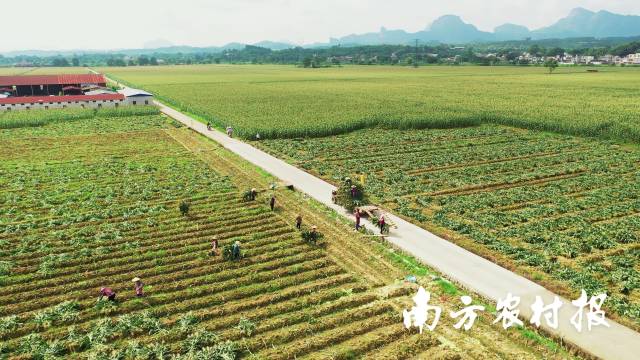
[0,0,640,52]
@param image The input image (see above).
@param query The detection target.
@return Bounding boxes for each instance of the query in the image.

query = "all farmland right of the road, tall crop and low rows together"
[105,66,640,356]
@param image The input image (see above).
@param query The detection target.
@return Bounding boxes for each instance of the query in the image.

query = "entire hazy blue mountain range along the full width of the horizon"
[4,8,640,57]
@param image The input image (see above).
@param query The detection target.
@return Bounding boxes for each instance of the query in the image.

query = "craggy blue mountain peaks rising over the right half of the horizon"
[326,8,640,46]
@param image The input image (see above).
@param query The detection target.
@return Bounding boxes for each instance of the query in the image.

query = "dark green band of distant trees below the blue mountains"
[0,41,640,67]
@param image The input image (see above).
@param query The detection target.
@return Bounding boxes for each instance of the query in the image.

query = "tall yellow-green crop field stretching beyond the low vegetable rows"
[101,65,640,143]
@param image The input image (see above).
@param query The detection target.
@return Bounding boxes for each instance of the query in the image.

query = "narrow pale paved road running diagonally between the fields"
[158,103,640,360]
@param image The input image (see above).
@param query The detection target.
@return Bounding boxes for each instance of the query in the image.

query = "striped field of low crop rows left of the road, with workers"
[0,115,570,359]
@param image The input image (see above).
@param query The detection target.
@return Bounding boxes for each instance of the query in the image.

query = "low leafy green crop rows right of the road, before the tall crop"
[256,125,640,328]
